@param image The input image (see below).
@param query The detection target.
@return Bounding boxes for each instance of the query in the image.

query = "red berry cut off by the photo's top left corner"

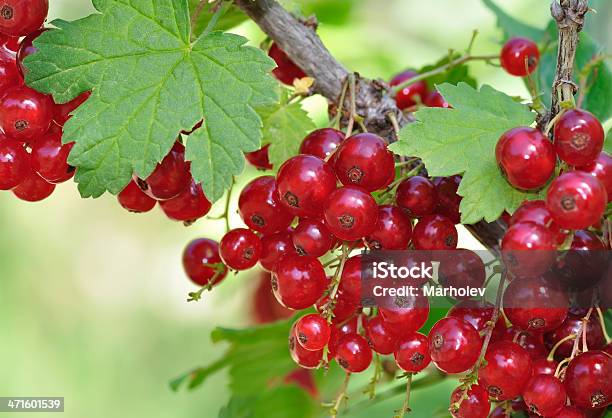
[0,0,49,36]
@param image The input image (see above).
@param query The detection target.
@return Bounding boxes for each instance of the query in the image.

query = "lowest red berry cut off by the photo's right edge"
[564,351,612,409]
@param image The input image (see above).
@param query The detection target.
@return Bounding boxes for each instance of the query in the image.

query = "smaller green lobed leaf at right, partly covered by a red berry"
[389,83,538,224]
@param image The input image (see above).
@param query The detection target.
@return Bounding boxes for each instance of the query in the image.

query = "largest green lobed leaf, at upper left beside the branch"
[25,0,277,201]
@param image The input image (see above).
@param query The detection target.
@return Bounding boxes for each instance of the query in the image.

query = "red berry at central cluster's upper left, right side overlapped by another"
[238,176,293,234]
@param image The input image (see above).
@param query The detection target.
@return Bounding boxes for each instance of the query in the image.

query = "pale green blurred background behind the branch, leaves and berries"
[0,0,612,418]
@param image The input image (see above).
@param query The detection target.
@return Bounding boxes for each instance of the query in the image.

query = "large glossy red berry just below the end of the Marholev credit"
[429,317,482,373]
